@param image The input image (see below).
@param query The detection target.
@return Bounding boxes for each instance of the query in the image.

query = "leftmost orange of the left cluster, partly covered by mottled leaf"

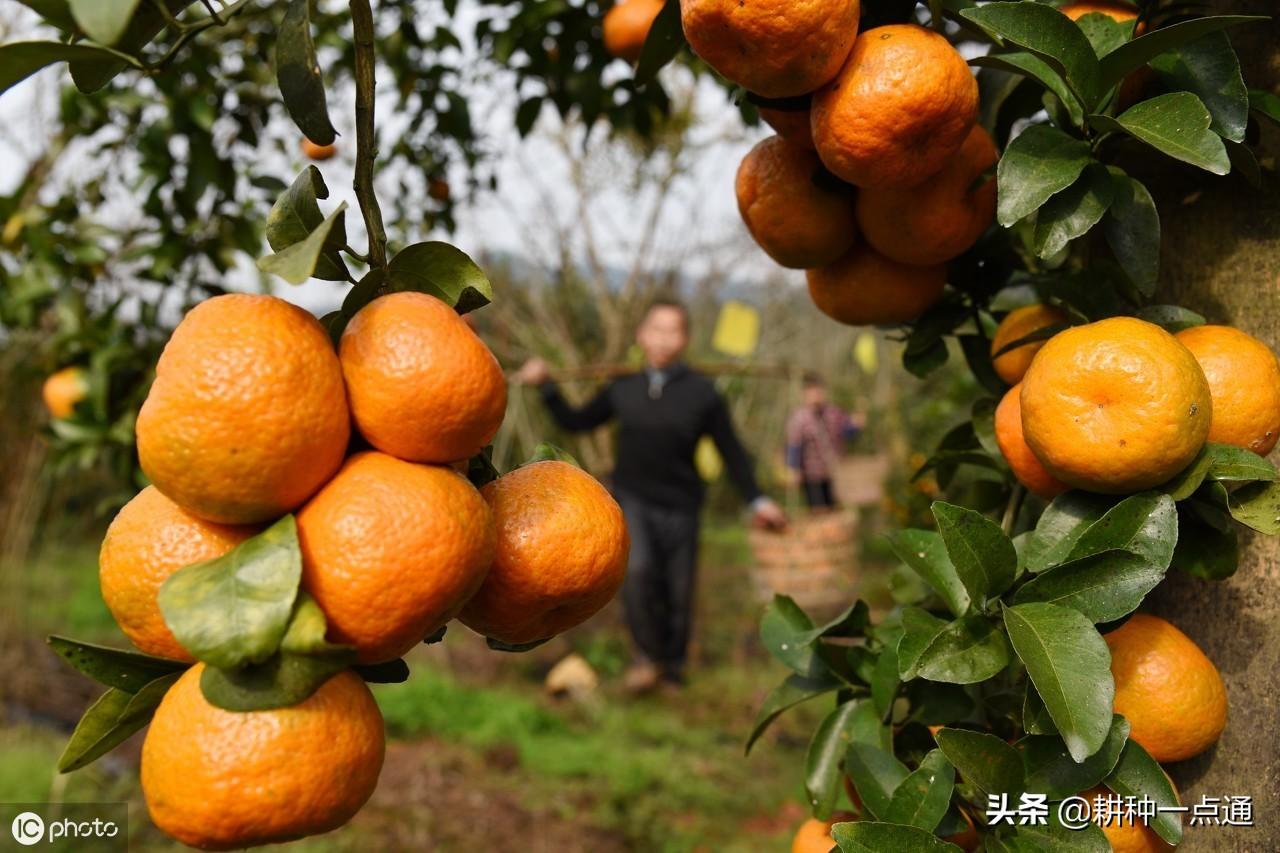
[97,485,257,661]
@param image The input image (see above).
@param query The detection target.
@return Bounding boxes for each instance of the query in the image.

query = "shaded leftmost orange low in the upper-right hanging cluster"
[736,136,858,269]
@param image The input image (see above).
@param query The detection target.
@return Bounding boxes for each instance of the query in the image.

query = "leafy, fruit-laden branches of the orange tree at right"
[640,0,1280,853]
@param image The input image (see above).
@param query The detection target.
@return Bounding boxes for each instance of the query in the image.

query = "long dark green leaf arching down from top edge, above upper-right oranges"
[960,3,1105,108]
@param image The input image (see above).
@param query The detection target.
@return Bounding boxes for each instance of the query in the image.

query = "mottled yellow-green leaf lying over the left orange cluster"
[159,515,302,669]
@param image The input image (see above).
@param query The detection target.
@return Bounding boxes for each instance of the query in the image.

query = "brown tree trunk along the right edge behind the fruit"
[1142,0,1280,853]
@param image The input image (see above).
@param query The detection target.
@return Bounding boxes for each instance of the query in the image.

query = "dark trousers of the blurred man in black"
[617,493,699,681]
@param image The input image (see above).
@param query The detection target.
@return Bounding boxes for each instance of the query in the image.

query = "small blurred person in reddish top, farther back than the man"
[787,373,864,510]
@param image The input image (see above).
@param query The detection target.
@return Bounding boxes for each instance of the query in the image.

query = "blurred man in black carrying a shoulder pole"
[517,300,786,692]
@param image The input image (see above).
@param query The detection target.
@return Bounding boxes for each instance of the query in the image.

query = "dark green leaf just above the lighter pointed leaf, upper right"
[1151,32,1249,142]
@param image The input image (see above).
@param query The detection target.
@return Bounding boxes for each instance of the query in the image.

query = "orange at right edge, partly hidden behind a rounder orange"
[1175,325,1280,456]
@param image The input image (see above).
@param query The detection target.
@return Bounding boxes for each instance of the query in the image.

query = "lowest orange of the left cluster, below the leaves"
[142,663,385,850]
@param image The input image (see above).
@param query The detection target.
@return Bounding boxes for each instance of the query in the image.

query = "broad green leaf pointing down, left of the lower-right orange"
[1005,602,1115,762]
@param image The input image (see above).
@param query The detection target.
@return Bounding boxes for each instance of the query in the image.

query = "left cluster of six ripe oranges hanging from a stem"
[91,293,628,848]
